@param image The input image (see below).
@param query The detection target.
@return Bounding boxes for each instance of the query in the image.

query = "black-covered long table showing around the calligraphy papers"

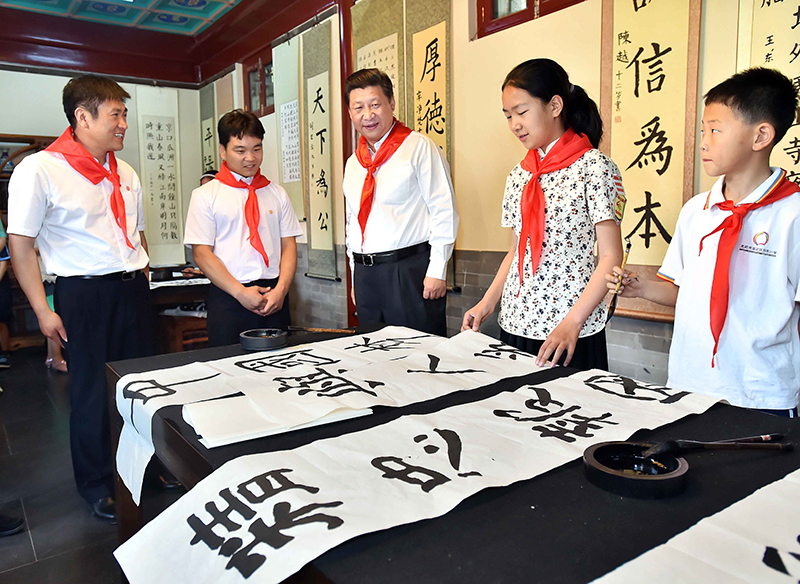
[107,334,800,584]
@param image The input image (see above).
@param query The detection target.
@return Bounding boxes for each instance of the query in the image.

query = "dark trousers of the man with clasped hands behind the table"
[206,278,291,347]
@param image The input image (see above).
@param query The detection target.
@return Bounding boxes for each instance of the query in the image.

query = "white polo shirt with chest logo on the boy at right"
[659,169,800,409]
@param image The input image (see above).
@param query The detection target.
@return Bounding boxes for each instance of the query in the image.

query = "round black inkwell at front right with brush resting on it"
[583,442,689,499]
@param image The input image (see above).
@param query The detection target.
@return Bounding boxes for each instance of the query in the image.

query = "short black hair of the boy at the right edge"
[705,67,797,144]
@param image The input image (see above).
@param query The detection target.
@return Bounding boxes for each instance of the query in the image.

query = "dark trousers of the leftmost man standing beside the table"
[54,273,154,503]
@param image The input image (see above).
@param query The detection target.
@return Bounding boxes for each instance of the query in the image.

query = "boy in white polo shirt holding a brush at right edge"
[607,68,800,417]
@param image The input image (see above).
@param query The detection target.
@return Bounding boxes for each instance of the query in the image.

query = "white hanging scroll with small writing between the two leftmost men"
[136,86,186,266]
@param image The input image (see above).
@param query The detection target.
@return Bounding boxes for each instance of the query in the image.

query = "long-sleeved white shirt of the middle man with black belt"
[343,132,458,280]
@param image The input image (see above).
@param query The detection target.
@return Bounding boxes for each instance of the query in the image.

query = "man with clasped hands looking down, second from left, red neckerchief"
[184,110,303,346]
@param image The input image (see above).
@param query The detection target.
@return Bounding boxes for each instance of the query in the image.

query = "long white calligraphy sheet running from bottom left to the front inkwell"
[114,370,714,584]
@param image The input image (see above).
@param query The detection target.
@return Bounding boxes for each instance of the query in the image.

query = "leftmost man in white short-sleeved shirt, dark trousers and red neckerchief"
[8,75,153,521]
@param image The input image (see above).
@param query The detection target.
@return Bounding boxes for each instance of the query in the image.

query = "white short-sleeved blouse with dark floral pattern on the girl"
[498,150,625,340]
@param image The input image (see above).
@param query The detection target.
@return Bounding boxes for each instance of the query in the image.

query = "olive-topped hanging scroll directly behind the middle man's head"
[350,0,413,126]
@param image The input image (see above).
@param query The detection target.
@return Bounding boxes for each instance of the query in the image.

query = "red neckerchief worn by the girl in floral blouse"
[517,128,593,295]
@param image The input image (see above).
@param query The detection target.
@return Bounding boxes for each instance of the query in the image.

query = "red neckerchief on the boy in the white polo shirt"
[699,170,800,367]
